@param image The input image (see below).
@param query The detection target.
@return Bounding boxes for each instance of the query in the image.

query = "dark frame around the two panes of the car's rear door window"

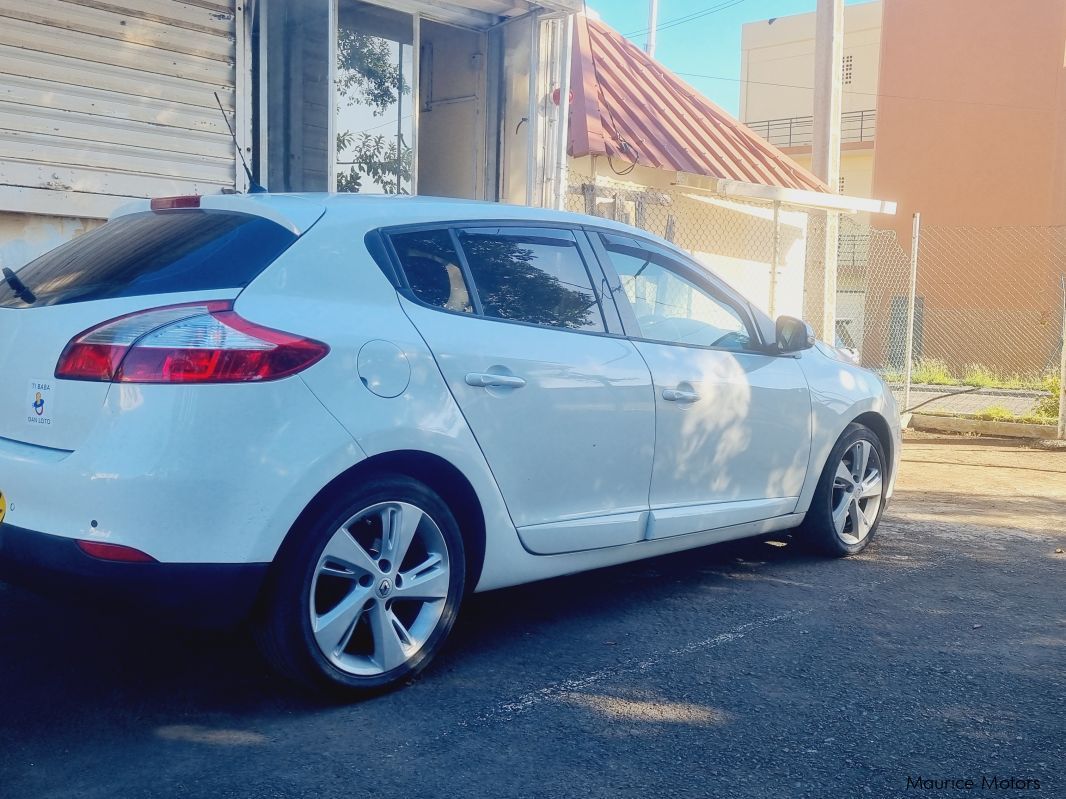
[373,218,630,338]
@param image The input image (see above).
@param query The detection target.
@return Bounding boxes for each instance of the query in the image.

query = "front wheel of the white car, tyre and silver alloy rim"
[800,423,887,557]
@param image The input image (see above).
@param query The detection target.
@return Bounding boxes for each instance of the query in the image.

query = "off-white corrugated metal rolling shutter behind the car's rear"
[0,0,241,216]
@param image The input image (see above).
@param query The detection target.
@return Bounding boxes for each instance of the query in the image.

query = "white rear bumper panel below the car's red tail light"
[0,377,362,564]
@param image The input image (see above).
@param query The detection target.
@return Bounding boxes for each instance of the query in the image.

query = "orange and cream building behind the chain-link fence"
[742,0,1066,373]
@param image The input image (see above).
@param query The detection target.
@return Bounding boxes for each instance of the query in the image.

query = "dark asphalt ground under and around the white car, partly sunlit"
[0,439,1066,799]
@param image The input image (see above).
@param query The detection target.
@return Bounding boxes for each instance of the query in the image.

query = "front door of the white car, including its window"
[595,233,811,538]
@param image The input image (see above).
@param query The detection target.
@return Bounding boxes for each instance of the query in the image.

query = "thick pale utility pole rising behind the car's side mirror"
[807,0,844,344]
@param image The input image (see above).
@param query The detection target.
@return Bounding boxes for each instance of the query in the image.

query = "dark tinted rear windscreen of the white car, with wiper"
[0,210,297,308]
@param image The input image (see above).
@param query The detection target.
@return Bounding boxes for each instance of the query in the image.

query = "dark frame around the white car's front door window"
[586,226,776,356]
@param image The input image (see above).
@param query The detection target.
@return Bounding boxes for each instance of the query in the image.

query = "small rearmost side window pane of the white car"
[391,230,473,313]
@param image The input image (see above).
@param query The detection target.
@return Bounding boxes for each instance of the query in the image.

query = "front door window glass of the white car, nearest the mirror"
[600,234,753,350]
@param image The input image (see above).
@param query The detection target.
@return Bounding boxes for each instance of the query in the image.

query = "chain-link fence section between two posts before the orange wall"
[899,225,1066,422]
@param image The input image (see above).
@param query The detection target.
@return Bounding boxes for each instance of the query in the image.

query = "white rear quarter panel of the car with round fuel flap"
[236,212,531,587]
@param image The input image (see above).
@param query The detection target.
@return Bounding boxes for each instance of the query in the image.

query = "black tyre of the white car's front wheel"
[796,423,889,557]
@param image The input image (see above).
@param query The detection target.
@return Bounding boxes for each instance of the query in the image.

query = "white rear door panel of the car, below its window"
[404,300,656,551]
